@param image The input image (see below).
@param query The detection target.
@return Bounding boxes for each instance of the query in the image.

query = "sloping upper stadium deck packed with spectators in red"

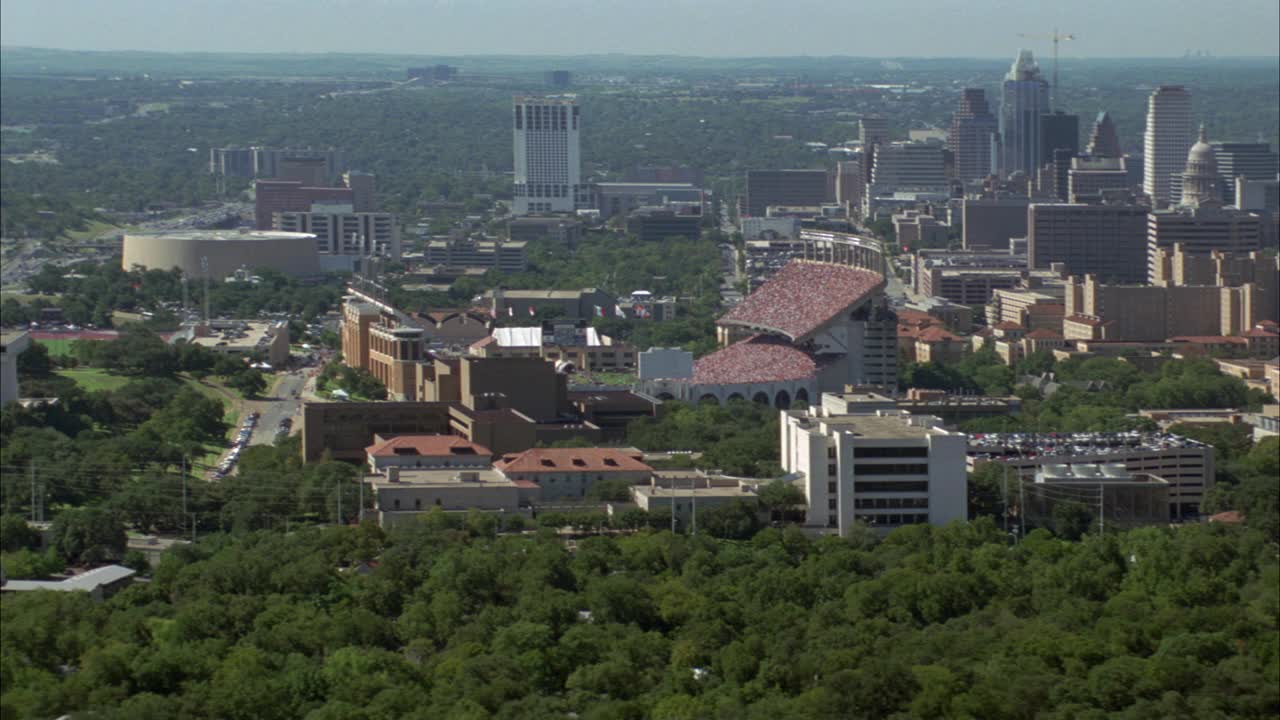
[719,260,884,340]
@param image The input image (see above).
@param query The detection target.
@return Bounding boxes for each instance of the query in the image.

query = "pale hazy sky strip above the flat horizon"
[0,0,1280,58]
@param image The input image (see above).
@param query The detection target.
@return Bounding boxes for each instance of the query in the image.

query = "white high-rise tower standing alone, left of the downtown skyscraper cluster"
[512,96,590,215]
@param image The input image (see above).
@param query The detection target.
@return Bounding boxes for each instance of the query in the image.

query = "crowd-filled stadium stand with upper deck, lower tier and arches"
[641,231,897,409]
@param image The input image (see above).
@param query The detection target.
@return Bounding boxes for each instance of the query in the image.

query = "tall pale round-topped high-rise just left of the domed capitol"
[1142,85,1196,202]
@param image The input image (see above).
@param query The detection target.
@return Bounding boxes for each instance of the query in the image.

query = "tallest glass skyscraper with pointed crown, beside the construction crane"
[1000,50,1050,176]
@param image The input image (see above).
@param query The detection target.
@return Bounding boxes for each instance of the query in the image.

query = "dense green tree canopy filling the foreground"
[0,514,1280,720]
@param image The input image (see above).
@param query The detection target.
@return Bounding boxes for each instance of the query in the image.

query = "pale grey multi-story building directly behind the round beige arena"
[273,204,401,263]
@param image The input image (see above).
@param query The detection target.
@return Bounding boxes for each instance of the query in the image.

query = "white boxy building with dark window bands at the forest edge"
[781,393,968,536]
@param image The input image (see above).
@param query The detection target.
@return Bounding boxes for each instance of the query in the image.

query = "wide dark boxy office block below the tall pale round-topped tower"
[1027,202,1147,282]
